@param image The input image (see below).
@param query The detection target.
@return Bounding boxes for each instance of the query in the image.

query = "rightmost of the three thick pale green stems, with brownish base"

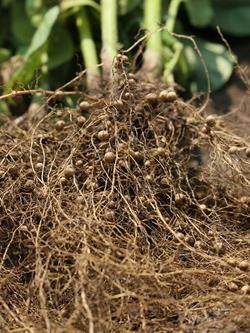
[143,0,162,77]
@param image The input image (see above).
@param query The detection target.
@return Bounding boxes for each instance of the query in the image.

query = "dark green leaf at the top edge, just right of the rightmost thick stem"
[185,0,213,27]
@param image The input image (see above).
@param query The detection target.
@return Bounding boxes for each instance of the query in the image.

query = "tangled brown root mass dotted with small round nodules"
[0,59,250,333]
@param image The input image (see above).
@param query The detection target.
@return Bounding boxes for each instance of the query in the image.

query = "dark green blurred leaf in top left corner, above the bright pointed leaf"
[11,1,35,47]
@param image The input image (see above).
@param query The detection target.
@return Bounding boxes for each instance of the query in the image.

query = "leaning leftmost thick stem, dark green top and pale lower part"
[76,8,100,90]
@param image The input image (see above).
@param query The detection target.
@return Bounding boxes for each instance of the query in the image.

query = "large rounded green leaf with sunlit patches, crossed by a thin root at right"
[184,39,234,91]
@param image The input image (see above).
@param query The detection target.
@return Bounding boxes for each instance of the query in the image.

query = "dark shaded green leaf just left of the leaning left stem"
[48,26,74,69]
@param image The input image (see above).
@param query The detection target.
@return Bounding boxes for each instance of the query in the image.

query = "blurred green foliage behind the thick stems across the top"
[0,0,250,111]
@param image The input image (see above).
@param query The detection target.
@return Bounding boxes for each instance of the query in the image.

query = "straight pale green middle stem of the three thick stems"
[101,0,118,78]
